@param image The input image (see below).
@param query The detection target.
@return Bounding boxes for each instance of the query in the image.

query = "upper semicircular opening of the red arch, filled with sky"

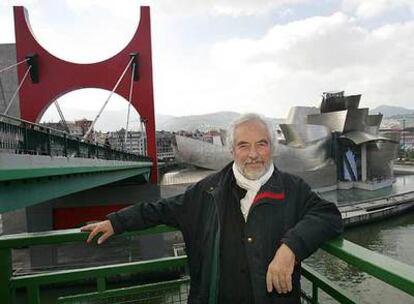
[20,0,140,63]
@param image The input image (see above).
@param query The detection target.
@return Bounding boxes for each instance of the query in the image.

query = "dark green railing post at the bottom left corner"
[0,248,13,303]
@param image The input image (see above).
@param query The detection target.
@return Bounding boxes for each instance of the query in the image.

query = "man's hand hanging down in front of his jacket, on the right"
[266,244,295,293]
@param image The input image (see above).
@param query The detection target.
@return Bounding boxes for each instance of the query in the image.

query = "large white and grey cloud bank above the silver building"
[181,13,414,116]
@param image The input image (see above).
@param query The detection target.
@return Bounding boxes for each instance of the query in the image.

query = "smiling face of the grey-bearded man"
[232,121,272,180]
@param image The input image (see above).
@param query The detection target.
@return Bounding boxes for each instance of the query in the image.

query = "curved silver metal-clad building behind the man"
[176,92,399,188]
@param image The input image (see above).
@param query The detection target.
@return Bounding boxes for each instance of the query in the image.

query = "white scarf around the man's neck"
[233,162,274,222]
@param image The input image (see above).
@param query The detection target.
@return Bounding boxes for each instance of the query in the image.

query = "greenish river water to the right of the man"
[304,176,414,304]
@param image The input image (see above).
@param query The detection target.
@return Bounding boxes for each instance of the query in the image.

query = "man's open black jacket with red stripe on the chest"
[108,163,342,304]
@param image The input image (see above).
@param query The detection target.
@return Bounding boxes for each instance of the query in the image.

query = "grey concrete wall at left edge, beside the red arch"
[0,43,20,118]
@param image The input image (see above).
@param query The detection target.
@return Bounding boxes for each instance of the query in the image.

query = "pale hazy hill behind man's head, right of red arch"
[157,112,284,131]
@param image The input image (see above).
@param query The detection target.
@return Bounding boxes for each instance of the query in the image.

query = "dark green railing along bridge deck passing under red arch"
[0,114,150,161]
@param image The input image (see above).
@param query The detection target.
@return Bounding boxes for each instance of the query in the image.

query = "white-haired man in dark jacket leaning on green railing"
[82,114,342,304]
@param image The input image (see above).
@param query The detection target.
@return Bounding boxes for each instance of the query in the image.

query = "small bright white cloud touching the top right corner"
[342,0,414,19]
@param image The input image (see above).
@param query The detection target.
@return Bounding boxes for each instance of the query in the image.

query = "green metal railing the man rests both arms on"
[0,226,414,304]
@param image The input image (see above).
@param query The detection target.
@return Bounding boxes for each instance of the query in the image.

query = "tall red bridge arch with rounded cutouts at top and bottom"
[14,6,158,183]
